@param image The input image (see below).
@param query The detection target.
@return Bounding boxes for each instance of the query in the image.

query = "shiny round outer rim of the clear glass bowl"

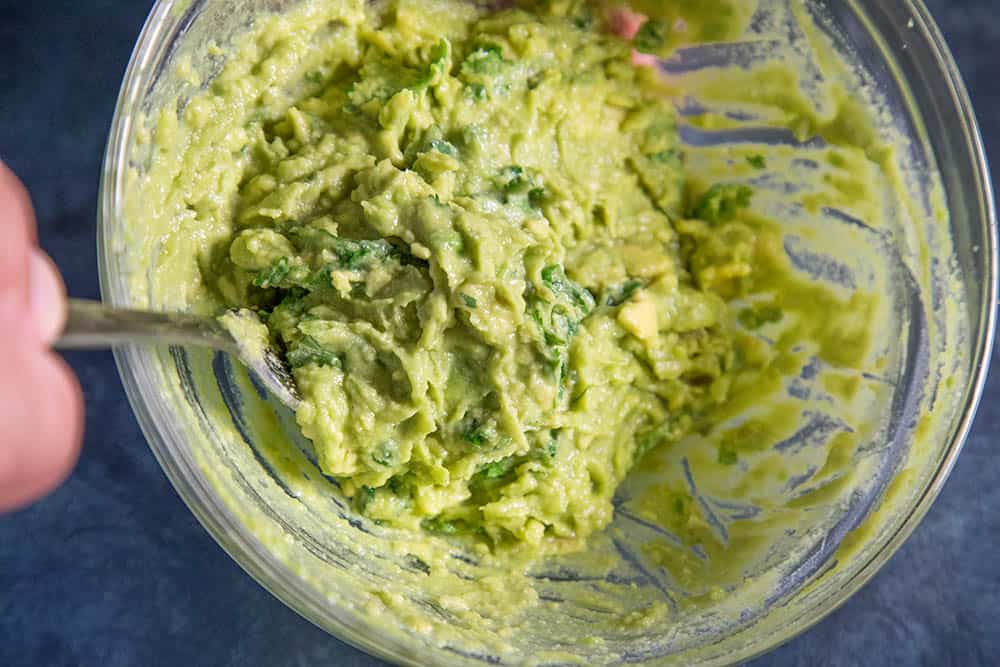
[97,0,998,665]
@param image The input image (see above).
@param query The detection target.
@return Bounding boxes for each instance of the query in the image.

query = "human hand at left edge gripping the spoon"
[0,162,83,512]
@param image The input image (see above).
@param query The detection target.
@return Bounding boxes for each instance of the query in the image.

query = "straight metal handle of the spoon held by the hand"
[55,299,235,352]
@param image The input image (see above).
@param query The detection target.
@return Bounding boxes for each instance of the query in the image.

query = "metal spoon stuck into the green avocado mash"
[55,299,302,410]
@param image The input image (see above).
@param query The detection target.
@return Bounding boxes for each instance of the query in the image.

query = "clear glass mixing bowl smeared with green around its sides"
[99,0,997,665]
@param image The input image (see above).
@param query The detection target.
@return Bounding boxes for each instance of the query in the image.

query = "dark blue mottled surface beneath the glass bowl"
[0,0,1000,667]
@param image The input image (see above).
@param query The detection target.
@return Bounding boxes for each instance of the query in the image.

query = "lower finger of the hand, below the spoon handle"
[0,350,83,511]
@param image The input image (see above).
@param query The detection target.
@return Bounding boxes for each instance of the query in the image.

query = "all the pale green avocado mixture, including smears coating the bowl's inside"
[118,0,957,664]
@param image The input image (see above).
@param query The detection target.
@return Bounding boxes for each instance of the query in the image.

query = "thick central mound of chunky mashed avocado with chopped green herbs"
[203,3,756,549]
